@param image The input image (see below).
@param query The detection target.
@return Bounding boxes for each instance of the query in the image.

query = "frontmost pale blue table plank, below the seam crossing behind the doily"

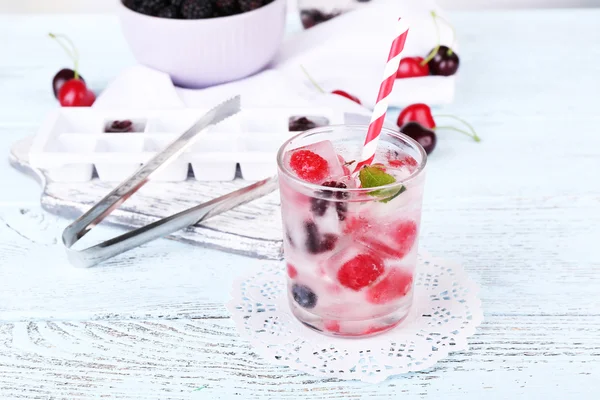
[0,316,600,400]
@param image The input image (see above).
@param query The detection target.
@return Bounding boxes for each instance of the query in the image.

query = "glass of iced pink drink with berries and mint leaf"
[278,126,426,336]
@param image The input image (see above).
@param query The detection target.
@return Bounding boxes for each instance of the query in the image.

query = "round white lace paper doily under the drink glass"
[227,255,483,383]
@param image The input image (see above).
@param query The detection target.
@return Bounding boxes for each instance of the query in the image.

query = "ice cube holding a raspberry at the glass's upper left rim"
[285,140,345,184]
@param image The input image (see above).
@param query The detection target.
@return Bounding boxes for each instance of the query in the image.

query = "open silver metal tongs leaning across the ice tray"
[62,96,277,268]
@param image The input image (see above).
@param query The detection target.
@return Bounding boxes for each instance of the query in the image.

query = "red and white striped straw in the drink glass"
[354,18,408,172]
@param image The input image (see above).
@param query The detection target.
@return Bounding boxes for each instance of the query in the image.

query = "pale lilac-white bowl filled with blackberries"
[119,0,286,88]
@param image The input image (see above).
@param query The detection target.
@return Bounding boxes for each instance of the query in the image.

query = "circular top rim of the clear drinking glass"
[277,124,427,193]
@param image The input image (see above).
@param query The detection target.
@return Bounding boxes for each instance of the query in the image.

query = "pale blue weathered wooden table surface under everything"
[0,10,600,399]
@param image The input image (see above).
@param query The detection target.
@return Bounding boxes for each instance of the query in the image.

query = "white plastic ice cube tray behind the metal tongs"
[29,108,344,182]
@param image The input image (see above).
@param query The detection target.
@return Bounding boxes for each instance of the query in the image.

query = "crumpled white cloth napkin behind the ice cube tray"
[94,0,457,114]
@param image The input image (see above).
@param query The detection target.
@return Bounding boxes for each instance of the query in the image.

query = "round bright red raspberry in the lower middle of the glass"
[337,254,384,291]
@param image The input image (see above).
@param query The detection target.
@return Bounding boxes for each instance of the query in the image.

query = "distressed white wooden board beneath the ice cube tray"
[9,138,282,259]
